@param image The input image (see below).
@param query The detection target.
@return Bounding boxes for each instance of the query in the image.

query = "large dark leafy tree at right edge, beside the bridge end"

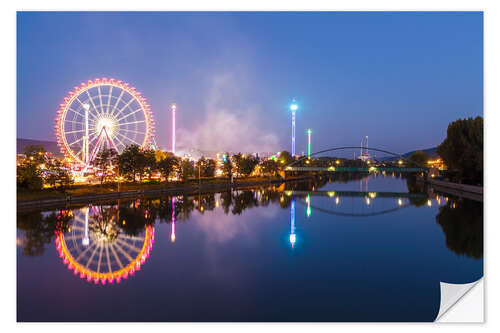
[438,117,483,185]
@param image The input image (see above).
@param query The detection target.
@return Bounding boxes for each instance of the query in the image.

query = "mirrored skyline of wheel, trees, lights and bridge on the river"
[17,177,483,284]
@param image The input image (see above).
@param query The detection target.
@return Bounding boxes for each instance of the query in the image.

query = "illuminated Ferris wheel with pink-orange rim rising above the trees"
[55,78,154,166]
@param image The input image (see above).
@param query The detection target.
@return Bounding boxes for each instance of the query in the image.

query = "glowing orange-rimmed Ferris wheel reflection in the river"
[55,206,154,285]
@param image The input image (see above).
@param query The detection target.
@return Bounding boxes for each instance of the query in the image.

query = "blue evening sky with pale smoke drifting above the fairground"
[17,12,483,153]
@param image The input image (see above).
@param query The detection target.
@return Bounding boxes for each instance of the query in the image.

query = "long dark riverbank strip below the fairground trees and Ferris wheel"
[17,176,312,210]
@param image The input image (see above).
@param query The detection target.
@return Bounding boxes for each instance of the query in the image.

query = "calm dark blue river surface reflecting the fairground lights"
[17,175,483,321]
